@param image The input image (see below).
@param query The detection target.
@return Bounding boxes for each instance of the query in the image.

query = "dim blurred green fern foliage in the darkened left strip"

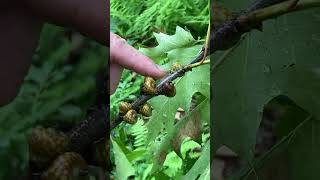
[0,24,108,179]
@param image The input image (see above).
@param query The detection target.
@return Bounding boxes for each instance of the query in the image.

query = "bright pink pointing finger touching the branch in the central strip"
[110,32,165,78]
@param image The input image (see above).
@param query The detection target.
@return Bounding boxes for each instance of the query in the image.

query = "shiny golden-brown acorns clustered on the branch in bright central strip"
[119,77,176,124]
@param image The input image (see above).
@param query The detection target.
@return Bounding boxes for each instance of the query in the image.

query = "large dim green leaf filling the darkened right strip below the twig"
[211,0,320,180]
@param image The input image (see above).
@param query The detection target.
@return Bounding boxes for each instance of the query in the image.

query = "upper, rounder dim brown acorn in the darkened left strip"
[28,127,69,167]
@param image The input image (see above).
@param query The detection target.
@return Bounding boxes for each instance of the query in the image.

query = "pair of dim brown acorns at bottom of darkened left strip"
[28,127,88,180]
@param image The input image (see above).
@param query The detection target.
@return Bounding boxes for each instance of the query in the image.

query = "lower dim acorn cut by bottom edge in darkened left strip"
[41,152,88,180]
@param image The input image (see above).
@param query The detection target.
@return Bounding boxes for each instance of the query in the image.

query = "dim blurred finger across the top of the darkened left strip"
[24,0,109,45]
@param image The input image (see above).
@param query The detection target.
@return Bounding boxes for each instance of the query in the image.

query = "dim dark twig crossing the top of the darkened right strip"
[210,0,320,54]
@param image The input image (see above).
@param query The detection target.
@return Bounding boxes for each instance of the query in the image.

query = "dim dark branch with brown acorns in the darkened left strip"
[26,71,109,180]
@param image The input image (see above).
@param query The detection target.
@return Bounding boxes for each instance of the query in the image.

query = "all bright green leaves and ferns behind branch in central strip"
[110,0,210,179]
